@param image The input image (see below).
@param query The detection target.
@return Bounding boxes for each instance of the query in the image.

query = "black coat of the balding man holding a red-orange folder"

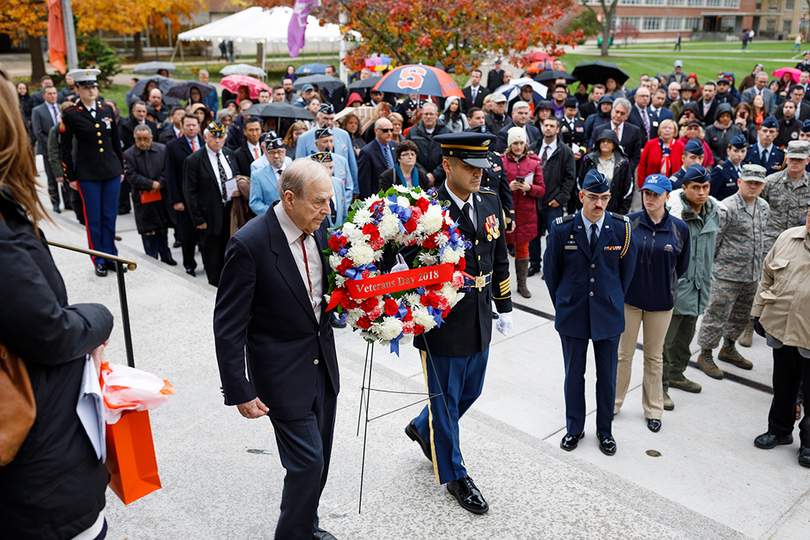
[124,142,172,234]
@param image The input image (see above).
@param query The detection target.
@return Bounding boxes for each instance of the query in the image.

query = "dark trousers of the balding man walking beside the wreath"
[270,359,337,540]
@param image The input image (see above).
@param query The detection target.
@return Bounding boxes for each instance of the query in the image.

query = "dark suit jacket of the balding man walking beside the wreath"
[214,208,338,420]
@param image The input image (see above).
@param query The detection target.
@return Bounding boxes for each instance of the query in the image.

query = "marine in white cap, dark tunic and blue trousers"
[59,69,124,276]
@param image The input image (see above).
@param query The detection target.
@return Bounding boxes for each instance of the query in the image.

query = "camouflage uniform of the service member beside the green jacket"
[698,192,772,349]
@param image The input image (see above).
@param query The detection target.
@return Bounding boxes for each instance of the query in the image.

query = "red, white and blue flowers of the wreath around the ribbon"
[324,186,472,353]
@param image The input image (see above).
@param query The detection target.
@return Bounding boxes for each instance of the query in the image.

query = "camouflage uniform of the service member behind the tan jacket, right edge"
[760,170,810,253]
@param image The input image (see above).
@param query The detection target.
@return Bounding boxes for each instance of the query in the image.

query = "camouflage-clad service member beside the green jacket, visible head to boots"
[698,164,770,379]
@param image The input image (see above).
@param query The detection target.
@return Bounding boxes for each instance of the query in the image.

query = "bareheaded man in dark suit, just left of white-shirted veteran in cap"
[166,114,205,277]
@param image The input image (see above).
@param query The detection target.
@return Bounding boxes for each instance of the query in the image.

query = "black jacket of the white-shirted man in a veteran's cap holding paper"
[183,147,239,235]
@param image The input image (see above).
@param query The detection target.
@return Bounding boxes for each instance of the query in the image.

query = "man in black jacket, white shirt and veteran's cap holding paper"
[183,122,235,287]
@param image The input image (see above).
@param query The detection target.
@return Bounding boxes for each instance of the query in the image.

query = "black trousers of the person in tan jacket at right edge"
[768,345,810,446]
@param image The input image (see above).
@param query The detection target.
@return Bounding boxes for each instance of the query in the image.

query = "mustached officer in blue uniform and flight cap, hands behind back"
[543,169,636,456]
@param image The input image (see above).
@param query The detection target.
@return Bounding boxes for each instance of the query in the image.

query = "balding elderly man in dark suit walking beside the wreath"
[214,159,340,540]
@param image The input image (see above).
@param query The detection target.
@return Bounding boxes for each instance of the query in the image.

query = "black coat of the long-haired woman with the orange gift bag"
[0,189,113,540]
